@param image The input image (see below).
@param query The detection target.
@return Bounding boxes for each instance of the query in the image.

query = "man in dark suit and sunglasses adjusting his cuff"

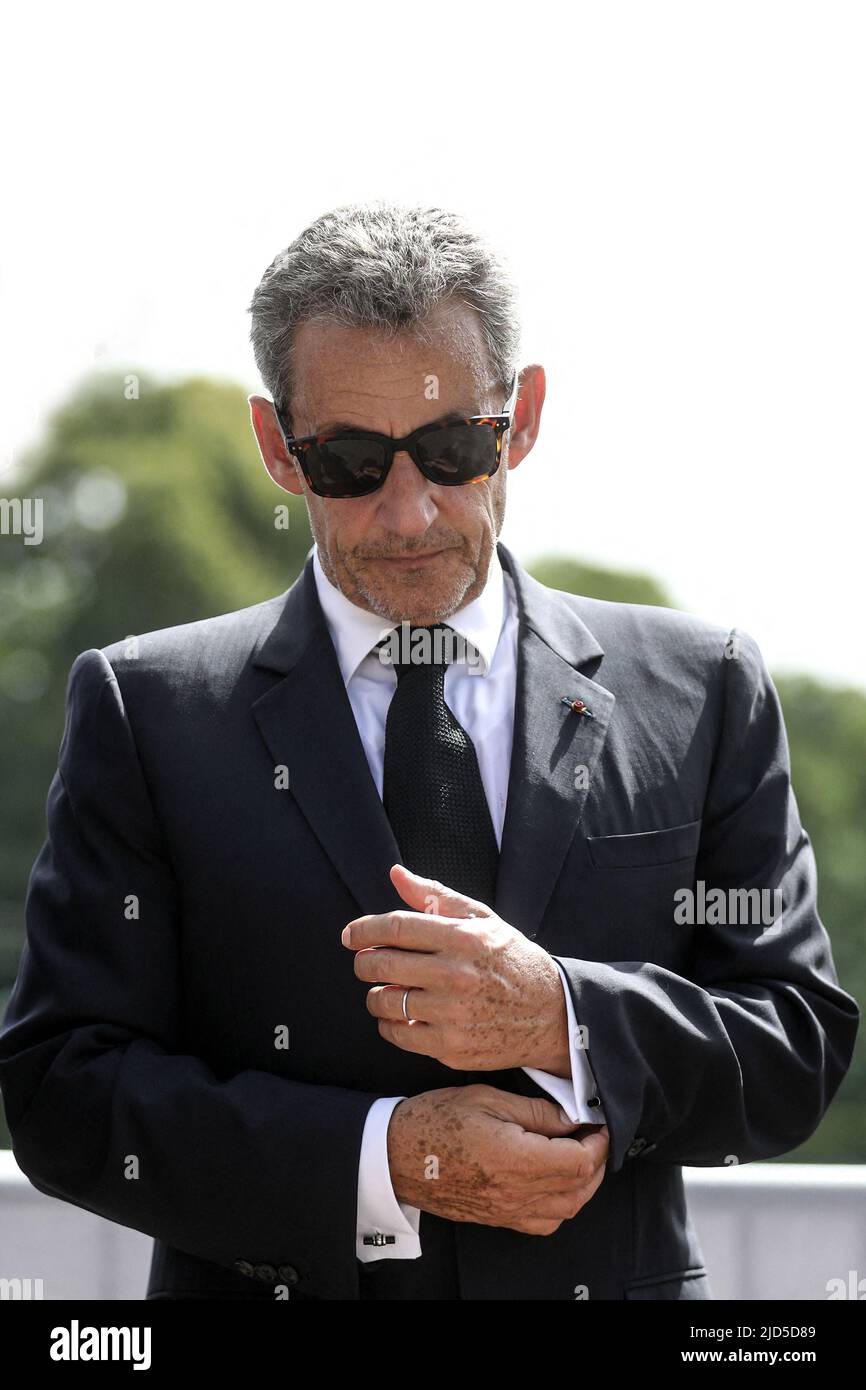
[0,209,859,1300]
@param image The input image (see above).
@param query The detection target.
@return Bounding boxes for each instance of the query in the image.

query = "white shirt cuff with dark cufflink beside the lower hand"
[356,1095,421,1264]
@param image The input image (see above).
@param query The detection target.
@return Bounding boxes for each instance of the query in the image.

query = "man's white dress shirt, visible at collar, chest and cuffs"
[313,548,605,1261]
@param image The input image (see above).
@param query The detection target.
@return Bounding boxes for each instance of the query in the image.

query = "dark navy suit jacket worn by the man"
[0,545,859,1300]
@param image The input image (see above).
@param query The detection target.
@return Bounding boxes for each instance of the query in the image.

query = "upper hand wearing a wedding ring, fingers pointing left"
[342,865,571,1076]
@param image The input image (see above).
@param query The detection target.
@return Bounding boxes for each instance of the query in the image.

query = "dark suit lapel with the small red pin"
[495,543,614,937]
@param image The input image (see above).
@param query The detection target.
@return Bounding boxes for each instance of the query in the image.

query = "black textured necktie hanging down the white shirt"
[382,623,499,908]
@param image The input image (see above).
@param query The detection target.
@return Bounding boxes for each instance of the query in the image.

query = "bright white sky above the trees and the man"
[0,0,866,687]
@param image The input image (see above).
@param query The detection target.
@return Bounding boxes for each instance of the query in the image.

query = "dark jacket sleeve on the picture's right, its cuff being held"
[557,632,859,1172]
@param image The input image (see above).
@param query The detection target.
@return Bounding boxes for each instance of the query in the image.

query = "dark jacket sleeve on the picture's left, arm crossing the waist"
[0,651,389,1298]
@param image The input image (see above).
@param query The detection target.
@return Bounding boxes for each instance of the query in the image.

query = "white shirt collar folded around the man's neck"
[313,545,505,685]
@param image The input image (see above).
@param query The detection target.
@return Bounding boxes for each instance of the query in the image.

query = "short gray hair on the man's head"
[249,199,520,414]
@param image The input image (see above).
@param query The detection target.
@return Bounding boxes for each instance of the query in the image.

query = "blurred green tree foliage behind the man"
[0,374,866,1162]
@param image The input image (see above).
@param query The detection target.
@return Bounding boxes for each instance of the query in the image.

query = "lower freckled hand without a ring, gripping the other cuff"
[388,1084,609,1236]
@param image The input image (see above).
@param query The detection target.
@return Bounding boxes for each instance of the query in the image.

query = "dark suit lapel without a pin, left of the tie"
[247,552,406,913]
